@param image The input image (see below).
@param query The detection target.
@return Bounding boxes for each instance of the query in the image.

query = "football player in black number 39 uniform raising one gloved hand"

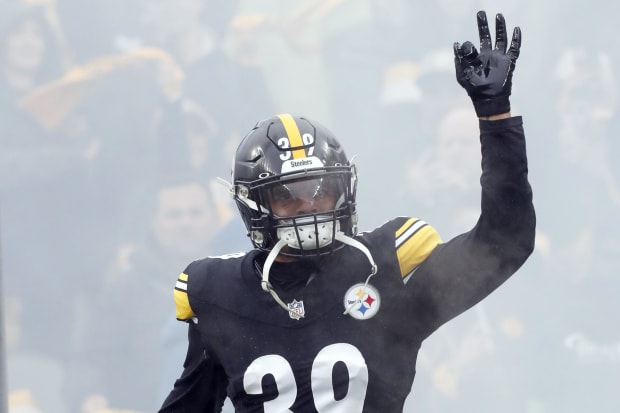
[160,11,535,413]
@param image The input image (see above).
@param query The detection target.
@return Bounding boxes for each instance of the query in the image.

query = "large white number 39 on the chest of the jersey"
[243,343,368,413]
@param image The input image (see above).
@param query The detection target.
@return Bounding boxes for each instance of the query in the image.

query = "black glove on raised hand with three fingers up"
[454,11,521,117]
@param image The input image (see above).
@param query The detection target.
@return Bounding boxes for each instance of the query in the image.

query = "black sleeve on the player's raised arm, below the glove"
[407,117,536,334]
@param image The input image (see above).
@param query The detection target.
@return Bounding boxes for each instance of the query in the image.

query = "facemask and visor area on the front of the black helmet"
[235,165,357,256]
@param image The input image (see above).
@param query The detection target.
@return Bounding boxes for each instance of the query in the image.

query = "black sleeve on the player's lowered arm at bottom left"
[159,323,228,413]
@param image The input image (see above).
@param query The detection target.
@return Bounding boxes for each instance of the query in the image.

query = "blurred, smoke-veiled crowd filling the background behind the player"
[0,0,620,413]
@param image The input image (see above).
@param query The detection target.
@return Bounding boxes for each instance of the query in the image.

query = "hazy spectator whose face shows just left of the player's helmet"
[69,173,221,412]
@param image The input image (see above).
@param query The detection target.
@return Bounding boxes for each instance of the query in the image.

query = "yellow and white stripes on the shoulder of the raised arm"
[394,218,441,277]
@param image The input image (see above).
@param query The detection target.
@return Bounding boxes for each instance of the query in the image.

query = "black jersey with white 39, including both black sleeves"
[161,117,535,413]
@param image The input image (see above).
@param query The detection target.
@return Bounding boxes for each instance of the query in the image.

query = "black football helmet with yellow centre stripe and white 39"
[232,114,357,256]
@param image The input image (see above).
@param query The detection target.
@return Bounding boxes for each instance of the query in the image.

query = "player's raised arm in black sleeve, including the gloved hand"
[407,12,536,332]
